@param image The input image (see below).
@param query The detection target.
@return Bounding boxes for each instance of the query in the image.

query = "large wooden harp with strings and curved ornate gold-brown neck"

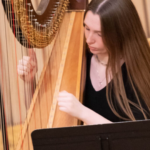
[0,0,87,150]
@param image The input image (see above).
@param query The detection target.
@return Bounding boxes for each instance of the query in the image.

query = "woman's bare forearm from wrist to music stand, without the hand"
[79,106,112,125]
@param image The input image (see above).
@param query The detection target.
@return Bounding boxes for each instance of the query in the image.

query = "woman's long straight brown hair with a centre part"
[85,0,150,120]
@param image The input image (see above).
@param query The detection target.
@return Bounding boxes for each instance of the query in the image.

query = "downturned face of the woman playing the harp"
[84,11,107,54]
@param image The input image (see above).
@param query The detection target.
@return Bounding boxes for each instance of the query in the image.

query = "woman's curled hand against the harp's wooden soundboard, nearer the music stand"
[58,91,84,119]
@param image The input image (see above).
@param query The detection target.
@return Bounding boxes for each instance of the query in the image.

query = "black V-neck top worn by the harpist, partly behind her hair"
[83,53,150,122]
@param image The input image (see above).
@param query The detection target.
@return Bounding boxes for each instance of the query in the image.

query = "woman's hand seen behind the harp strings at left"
[17,49,38,82]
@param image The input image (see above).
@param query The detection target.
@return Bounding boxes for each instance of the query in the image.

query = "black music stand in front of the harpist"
[31,120,150,150]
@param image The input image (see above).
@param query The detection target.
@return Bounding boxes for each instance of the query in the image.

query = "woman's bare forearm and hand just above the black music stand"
[58,91,111,125]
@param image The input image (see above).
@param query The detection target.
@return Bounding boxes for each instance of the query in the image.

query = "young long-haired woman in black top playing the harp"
[58,0,150,124]
